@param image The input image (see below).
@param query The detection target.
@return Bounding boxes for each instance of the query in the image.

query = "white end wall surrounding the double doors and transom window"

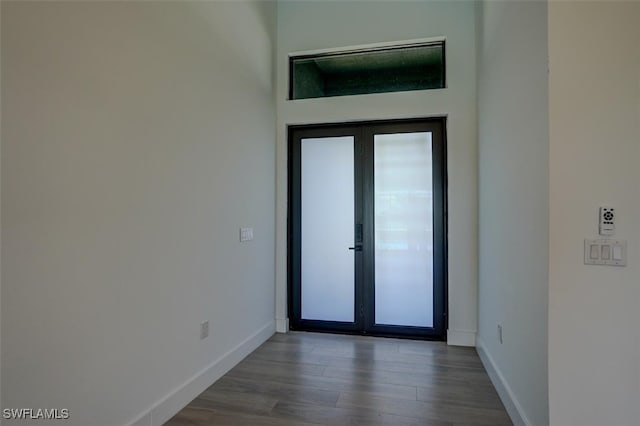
[276,1,477,345]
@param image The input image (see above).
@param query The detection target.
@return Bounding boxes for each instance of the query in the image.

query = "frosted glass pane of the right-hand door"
[374,133,433,327]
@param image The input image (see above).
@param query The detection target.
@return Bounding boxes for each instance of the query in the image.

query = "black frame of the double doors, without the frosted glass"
[287,117,447,340]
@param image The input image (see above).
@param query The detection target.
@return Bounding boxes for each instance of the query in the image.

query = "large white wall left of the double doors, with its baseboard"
[2,1,275,426]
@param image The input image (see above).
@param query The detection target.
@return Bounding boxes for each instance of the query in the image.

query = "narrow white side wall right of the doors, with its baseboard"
[478,1,549,426]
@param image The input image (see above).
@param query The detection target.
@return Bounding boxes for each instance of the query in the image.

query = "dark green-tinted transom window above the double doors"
[289,41,445,99]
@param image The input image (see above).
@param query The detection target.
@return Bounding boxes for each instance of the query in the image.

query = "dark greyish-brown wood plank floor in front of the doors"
[167,332,512,426]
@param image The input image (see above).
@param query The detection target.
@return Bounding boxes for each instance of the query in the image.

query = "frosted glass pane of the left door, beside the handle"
[301,136,355,322]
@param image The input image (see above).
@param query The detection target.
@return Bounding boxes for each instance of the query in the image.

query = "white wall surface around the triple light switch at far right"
[549,2,640,426]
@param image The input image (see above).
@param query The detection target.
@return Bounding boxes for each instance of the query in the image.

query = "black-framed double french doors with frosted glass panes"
[289,118,446,339]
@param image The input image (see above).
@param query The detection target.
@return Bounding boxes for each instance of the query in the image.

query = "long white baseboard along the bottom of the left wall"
[128,322,275,426]
